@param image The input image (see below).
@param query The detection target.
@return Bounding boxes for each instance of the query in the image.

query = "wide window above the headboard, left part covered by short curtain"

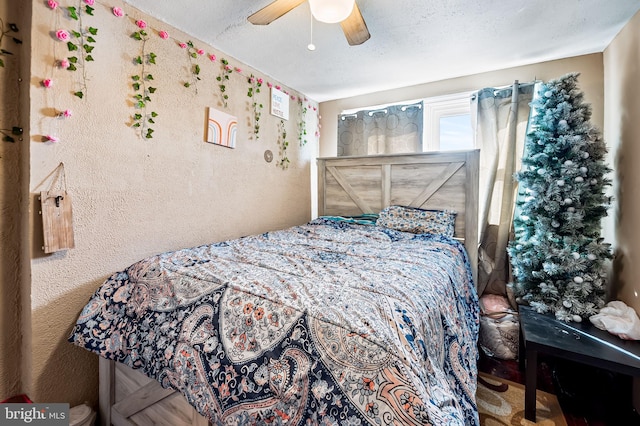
[338,92,474,156]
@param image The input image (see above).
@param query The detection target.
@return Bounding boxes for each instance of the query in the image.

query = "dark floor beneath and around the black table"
[478,351,640,426]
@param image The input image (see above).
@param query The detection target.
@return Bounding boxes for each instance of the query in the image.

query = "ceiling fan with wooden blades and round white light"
[249,0,371,46]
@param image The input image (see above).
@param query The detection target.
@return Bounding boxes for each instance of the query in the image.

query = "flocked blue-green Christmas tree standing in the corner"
[508,74,612,322]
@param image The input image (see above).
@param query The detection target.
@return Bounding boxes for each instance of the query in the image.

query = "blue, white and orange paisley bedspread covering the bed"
[69,219,479,426]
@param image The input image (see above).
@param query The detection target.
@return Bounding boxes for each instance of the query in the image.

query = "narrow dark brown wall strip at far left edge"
[0,0,30,400]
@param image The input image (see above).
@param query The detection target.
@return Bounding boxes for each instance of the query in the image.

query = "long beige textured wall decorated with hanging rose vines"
[25,0,317,404]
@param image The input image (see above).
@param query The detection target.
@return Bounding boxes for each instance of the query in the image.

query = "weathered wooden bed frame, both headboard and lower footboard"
[99,150,480,426]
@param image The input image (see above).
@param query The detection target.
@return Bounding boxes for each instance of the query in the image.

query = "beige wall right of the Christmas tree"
[604,10,640,316]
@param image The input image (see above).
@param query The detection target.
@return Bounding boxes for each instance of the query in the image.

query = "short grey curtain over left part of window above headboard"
[338,102,424,156]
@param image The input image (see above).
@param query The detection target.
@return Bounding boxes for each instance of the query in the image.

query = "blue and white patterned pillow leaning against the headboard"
[376,206,456,237]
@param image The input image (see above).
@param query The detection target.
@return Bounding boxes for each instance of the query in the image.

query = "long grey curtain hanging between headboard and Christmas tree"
[471,81,535,303]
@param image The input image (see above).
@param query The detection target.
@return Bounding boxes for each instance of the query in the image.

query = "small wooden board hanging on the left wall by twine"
[40,163,75,253]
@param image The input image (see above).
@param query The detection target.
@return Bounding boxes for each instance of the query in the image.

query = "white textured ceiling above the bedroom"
[125,0,640,102]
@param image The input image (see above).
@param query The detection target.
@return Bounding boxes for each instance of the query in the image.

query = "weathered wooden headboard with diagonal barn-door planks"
[318,150,480,279]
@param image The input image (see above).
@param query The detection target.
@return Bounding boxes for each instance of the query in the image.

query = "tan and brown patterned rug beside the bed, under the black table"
[476,373,567,426]
